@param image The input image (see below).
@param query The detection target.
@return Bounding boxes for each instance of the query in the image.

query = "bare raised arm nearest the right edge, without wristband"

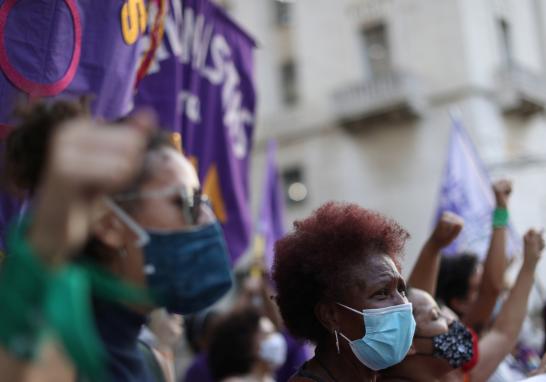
[470,230,544,382]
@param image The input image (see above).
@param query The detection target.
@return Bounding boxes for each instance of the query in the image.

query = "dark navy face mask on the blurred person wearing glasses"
[108,201,232,314]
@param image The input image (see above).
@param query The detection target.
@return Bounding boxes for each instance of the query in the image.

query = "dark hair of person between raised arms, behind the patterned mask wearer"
[436,253,478,314]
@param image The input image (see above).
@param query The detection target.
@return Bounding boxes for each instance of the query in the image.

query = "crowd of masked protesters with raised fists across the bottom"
[0,101,546,382]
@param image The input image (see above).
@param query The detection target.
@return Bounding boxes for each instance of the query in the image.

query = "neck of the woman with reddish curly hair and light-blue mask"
[315,343,377,382]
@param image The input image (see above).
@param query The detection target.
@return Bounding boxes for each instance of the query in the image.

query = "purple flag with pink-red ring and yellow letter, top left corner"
[0,0,148,124]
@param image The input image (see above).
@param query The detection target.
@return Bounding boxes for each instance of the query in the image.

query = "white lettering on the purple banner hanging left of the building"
[149,1,254,159]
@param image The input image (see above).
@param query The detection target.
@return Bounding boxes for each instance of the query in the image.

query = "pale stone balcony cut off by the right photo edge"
[497,65,546,115]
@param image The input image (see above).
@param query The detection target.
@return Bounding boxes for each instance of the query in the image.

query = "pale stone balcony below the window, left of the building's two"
[333,72,425,124]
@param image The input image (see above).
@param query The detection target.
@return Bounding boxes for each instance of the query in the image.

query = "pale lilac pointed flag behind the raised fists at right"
[436,120,521,259]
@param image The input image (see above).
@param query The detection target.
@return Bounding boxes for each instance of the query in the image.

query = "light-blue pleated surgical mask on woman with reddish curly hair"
[338,303,415,370]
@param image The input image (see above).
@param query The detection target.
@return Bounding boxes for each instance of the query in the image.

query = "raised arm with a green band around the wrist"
[463,180,512,333]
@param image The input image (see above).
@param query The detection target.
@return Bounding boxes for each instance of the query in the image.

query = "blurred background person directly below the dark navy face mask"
[139,309,182,382]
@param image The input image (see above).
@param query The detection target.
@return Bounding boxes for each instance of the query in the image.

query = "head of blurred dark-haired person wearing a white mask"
[209,308,286,382]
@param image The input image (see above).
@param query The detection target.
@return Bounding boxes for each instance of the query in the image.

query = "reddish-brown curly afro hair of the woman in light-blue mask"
[273,202,409,343]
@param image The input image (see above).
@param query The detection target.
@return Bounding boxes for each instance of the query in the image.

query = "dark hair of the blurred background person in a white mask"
[208,308,261,381]
